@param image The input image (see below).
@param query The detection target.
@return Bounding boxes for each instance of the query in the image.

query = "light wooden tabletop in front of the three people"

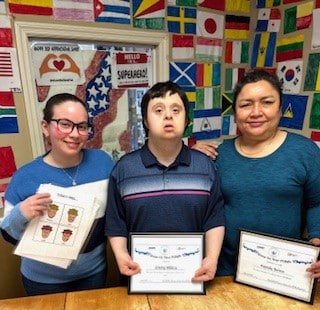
[0,277,320,310]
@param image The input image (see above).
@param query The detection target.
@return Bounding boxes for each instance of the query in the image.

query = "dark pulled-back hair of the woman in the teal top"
[232,69,282,111]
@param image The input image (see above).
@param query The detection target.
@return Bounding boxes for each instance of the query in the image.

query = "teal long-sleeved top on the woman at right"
[216,133,320,275]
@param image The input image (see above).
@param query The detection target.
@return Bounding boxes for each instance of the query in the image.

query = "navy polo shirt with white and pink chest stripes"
[106,145,224,237]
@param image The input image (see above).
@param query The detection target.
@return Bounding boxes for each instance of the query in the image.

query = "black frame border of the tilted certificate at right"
[234,229,320,305]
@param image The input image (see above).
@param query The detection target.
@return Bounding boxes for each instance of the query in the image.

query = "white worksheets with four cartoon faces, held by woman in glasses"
[15,184,100,268]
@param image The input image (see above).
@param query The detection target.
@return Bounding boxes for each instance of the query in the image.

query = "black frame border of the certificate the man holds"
[128,232,206,295]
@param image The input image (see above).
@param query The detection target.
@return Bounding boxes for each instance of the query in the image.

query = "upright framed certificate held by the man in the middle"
[128,233,206,295]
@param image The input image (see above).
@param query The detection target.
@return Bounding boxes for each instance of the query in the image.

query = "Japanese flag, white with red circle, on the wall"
[197,11,224,39]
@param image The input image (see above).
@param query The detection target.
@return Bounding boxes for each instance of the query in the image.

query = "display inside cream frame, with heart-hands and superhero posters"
[30,39,154,162]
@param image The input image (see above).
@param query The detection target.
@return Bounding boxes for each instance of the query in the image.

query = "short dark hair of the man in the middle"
[141,81,190,137]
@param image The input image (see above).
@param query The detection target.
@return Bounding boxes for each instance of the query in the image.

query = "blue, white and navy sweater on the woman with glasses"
[1,149,114,283]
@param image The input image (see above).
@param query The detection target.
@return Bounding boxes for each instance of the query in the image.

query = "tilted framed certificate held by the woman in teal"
[234,230,320,304]
